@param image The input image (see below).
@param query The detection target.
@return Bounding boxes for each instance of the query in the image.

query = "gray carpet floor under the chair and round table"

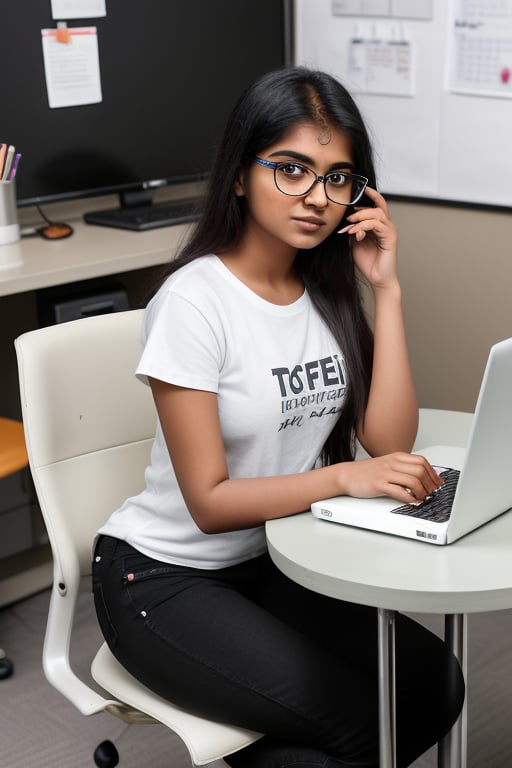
[0,591,512,768]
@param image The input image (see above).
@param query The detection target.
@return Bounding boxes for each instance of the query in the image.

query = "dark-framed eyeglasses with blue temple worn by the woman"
[254,157,368,205]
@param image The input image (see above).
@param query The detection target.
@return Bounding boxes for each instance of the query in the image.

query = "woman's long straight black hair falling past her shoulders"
[158,67,375,464]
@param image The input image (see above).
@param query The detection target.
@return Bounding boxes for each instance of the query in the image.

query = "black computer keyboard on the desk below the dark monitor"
[84,199,200,231]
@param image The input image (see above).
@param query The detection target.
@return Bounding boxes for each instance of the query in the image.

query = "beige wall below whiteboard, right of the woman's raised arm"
[390,201,512,411]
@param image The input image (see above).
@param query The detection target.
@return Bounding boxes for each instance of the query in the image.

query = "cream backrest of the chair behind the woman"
[15,310,156,583]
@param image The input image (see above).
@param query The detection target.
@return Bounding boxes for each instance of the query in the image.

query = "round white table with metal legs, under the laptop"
[266,444,512,768]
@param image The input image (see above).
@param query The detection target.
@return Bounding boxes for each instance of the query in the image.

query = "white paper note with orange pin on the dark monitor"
[41,27,102,109]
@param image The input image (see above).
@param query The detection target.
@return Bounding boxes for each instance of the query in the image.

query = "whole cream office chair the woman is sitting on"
[15,311,260,768]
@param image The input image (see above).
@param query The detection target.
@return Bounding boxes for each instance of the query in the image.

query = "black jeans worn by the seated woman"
[93,537,464,768]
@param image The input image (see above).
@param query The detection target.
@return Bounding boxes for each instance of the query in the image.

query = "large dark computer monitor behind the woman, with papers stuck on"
[0,0,289,228]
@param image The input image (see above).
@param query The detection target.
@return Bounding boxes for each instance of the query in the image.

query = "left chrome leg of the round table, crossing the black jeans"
[377,608,396,768]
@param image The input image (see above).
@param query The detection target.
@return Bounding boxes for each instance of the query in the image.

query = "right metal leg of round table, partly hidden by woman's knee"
[437,613,467,768]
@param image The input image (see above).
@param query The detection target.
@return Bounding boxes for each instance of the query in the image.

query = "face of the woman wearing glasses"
[235,123,358,249]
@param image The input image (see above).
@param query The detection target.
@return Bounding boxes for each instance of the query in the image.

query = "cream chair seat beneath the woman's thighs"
[91,643,261,765]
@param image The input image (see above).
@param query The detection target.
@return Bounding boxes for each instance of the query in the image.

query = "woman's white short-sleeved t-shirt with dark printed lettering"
[100,256,346,569]
